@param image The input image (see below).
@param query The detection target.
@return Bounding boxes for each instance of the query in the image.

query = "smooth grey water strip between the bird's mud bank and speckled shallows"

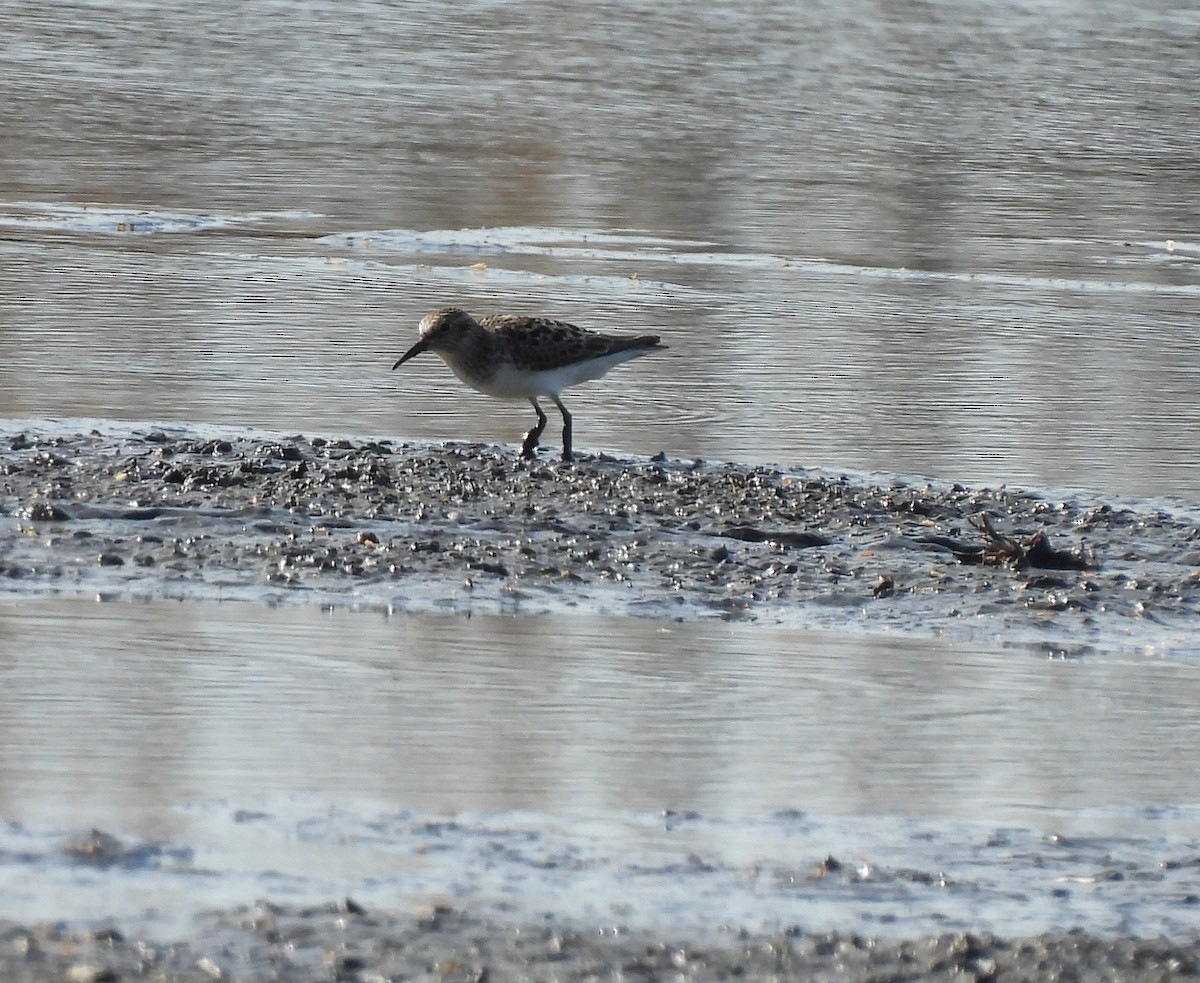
[0,600,1200,837]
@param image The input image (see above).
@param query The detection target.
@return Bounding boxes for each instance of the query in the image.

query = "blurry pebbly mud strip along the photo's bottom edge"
[0,899,1200,983]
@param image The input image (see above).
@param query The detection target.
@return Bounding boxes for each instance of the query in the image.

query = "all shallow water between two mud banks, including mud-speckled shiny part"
[0,600,1200,934]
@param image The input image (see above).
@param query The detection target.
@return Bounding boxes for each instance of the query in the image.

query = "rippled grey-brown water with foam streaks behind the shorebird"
[0,0,1200,498]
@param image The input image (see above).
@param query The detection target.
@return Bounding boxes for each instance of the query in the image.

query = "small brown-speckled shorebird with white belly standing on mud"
[392,307,666,461]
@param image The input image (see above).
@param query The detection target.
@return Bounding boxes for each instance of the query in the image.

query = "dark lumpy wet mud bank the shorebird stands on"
[7,425,1200,654]
